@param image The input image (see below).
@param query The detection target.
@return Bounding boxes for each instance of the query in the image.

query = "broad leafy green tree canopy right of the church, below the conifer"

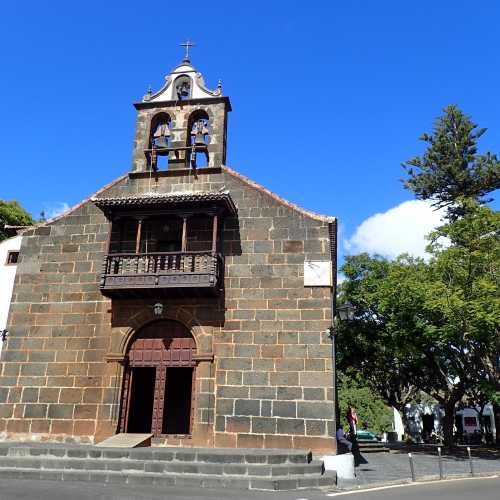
[339,204,500,444]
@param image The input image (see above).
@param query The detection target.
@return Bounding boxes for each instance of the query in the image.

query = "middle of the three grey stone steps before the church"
[0,455,324,477]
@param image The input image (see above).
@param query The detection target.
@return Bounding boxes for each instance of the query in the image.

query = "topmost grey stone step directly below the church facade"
[0,442,312,465]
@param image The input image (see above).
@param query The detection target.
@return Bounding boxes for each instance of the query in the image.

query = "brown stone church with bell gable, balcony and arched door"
[0,49,336,451]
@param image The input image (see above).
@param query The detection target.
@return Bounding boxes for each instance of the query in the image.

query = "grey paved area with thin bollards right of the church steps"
[346,450,500,488]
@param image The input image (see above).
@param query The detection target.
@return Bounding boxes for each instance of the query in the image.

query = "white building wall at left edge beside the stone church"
[0,236,22,352]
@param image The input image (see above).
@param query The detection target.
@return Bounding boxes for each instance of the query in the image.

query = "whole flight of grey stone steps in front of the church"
[0,442,336,491]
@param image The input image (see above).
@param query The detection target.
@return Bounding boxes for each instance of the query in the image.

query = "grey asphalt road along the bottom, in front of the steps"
[0,478,500,500]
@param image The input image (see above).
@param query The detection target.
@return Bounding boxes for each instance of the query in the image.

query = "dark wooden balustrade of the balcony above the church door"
[100,252,224,297]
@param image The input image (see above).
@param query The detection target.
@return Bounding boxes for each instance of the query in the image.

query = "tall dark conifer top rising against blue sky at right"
[403,105,500,220]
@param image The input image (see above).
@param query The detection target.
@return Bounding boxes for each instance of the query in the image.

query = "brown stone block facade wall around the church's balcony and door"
[0,167,333,450]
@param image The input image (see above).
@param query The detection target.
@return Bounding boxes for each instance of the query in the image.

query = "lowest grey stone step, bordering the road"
[0,467,336,491]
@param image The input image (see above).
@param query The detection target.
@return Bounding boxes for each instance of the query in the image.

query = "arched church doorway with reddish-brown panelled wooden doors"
[120,320,196,436]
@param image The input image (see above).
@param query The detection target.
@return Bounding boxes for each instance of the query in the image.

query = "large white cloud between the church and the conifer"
[344,200,443,258]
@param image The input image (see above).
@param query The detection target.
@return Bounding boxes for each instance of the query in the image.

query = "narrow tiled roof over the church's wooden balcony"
[91,191,236,214]
